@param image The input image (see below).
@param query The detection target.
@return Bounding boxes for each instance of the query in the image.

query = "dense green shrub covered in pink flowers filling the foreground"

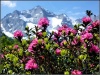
[0,10,100,75]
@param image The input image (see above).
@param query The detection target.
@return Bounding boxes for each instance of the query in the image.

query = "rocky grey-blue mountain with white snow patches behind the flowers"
[1,6,73,37]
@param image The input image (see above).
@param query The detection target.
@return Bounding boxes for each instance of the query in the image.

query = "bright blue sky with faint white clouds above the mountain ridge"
[1,0,99,19]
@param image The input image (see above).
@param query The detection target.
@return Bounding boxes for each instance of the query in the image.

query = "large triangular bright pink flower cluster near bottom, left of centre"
[25,58,38,70]
